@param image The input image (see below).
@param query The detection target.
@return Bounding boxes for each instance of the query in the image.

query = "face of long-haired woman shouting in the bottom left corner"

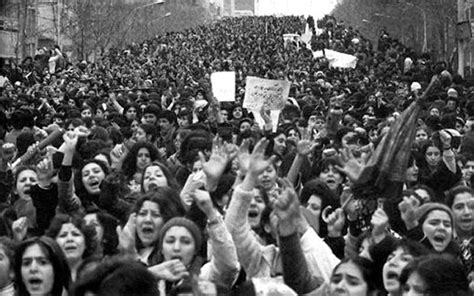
[21,244,54,295]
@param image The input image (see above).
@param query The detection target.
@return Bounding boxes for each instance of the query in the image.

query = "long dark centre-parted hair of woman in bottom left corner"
[14,236,71,296]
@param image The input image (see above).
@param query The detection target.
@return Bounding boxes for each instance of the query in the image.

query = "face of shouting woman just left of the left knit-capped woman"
[137,200,163,247]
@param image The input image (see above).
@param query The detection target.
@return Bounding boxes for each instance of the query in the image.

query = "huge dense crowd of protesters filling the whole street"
[0,16,474,296]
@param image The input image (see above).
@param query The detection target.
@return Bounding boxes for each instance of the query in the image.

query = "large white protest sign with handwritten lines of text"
[243,76,290,111]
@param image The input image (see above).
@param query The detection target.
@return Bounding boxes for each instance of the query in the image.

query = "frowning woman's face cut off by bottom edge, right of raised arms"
[329,262,368,296]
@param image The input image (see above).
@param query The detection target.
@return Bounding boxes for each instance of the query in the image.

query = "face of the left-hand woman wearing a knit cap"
[162,226,196,266]
